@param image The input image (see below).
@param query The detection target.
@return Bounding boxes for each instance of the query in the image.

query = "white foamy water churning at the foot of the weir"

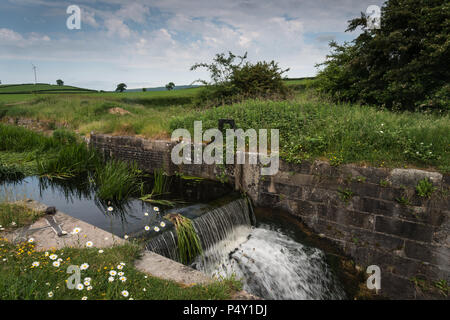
[194,225,345,300]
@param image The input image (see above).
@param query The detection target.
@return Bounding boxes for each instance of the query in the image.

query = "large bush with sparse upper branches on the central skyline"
[191,52,289,104]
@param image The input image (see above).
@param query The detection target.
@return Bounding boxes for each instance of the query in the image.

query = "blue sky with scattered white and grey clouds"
[0,0,384,90]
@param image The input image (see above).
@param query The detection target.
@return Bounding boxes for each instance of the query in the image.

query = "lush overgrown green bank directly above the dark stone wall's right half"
[171,91,450,172]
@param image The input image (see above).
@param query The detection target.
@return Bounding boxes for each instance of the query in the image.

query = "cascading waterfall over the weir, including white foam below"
[147,199,345,300]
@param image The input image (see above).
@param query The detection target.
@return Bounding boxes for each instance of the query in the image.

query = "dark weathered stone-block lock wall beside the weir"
[90,134,450,299]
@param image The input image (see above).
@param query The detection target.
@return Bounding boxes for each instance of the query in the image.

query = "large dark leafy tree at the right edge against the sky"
[318,0,450,110]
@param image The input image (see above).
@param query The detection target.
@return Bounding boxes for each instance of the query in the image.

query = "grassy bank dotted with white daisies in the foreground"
[0,238,237,300]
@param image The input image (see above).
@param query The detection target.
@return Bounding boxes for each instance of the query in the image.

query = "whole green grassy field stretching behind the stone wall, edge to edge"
[0,79,450,172]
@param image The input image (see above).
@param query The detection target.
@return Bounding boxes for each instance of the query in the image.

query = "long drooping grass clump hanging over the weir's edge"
[164,213,202,264]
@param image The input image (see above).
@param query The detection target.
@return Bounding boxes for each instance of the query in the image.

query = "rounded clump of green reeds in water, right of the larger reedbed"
[96,160,142,201]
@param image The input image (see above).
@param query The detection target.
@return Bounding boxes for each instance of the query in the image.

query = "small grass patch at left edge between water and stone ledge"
[0,203,43,231]
